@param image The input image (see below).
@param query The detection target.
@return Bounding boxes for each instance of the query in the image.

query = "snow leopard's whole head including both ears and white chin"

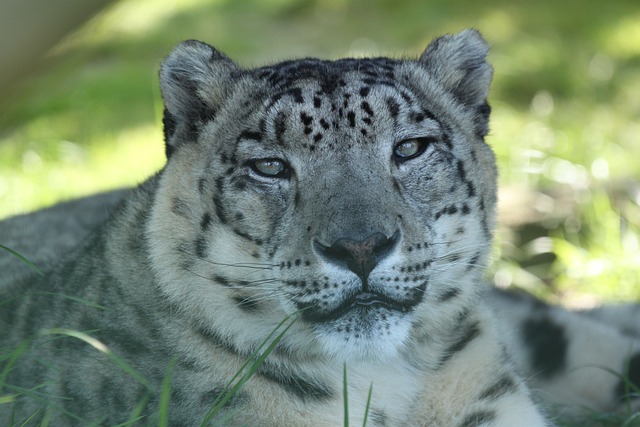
[149,31,496,360]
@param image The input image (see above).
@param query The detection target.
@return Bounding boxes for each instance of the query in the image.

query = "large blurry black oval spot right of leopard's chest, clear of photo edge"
[522,317,568,377]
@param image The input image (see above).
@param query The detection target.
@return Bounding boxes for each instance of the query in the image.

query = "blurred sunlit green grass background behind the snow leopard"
[0,0,640,306]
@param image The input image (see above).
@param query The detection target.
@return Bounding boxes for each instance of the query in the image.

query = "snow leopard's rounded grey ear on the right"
[418,30,493,108]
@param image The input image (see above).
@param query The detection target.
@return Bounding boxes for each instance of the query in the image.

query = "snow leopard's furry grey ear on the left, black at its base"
[160,40,240,158]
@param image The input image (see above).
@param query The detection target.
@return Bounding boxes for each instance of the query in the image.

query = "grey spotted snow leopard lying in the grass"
[0,30,640,427]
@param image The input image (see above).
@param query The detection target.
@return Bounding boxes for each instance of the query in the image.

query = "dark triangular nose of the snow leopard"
[315,231,400,287]
